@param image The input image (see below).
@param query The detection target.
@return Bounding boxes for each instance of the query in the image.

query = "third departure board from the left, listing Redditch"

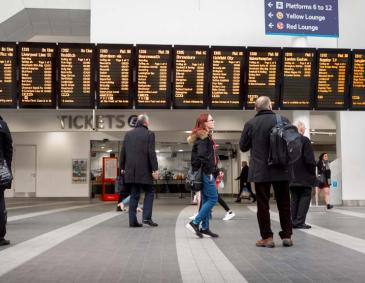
[58,43,95,108]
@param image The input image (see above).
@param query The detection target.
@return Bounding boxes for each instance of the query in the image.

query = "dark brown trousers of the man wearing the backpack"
[255,181,293,239]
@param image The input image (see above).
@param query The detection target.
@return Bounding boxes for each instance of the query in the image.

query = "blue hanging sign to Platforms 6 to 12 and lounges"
[265,0,339,37]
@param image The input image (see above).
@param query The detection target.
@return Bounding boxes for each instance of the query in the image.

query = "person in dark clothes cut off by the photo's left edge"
[0,116,13,246]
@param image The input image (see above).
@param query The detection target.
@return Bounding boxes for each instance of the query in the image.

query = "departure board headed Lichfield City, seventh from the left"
[209,46,245,109]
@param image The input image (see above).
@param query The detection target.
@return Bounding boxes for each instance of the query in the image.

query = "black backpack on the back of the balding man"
[268,114,302,167]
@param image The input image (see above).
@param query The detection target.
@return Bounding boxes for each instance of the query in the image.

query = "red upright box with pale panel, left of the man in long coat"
[101,157,118,201]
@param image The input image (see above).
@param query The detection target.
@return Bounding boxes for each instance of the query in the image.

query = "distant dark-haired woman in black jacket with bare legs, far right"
[317,152,333,209]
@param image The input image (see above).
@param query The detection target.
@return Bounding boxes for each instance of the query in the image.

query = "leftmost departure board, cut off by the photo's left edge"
[0,42,17,108]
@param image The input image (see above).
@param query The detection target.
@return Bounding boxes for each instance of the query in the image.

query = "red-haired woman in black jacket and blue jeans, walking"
[186,113,218,238]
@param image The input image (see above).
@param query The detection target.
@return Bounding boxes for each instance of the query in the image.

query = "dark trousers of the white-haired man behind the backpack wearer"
[290,186,312,226]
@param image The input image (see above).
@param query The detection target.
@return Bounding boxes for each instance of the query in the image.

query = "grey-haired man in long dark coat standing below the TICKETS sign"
[120,114,159,227]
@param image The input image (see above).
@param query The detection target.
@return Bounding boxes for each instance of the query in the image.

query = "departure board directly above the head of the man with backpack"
[246,47,281,109]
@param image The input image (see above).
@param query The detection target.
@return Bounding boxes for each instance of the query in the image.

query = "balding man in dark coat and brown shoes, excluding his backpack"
[240,96,293,248]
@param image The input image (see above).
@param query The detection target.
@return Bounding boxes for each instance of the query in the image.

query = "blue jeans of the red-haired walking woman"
[193,174,218,230]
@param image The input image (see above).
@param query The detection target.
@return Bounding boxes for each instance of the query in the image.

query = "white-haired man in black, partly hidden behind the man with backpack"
[290,121,316,229]
